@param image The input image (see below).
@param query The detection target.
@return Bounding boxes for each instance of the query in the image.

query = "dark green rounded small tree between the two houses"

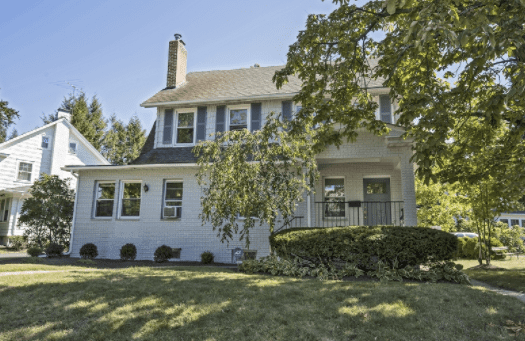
[18,173,75,247]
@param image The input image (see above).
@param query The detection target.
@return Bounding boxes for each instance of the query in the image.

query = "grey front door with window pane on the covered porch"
[363,178,392,226]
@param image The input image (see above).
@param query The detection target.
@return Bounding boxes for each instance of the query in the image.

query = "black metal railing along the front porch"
[312,201,404,227]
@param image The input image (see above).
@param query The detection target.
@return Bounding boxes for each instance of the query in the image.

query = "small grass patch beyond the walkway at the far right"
[456,256,525,292]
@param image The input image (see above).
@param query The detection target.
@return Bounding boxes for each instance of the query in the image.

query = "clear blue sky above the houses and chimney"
[0,0,335,133]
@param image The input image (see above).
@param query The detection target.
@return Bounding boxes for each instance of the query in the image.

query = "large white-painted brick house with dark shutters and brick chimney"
[64,35,417,262]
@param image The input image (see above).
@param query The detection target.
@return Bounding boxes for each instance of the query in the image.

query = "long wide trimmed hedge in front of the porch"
[270,226,457,270]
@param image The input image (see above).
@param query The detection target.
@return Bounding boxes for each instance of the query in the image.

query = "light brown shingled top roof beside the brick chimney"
[141,59,384,107]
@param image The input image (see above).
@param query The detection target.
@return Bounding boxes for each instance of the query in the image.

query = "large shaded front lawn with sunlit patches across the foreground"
[0,264,525,340]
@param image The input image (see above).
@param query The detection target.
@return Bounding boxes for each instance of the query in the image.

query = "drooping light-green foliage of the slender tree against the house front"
[194,113,319,246]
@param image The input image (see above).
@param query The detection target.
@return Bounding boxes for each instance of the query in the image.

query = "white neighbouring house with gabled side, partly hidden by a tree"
[0,109,109,245]
